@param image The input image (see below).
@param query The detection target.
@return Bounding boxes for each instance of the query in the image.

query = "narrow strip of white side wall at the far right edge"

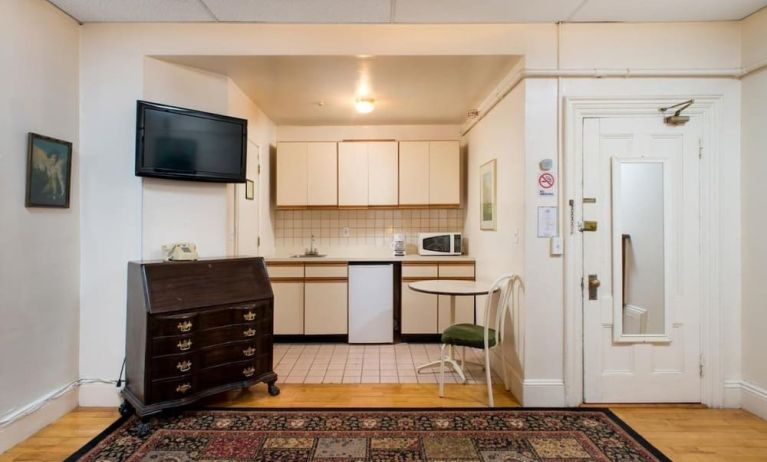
[741,6,767,418]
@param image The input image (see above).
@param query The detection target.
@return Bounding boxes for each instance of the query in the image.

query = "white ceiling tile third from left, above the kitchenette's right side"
[394,0,583,23]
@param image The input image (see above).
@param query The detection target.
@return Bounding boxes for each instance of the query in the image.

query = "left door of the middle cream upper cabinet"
[338,142,368,207]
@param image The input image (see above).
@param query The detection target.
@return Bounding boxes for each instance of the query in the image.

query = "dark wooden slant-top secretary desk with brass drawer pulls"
[120,258,279,417]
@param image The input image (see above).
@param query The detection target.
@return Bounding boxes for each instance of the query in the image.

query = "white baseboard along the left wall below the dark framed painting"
[0,382,77,454]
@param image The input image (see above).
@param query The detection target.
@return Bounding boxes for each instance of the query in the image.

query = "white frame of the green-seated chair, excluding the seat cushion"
[439,274,524,407]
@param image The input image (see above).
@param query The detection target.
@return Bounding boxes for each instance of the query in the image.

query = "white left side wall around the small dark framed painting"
[0,0,80,452]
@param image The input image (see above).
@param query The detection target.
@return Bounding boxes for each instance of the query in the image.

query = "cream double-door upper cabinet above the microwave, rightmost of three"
[399,141,461,206]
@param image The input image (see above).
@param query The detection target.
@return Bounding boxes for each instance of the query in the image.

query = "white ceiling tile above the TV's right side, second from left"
[204,0,391,23]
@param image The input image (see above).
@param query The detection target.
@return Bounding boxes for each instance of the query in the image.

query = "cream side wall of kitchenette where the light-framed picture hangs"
[464,72,526,400]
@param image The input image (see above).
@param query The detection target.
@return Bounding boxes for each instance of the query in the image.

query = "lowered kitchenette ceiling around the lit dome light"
[158,56,519,125]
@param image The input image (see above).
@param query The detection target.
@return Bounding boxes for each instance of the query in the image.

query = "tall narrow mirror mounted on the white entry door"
[613,161,667,340]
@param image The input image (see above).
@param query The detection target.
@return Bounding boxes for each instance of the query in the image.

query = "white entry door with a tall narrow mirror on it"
[578,116,701,403]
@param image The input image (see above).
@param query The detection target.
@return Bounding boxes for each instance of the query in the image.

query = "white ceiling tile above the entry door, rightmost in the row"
[571,0,767,22]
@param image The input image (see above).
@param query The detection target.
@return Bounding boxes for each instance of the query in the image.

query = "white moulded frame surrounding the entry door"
[562,94,725,407]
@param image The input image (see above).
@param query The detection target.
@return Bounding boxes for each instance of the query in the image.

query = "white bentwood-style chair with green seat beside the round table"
[439,274,520,407]
